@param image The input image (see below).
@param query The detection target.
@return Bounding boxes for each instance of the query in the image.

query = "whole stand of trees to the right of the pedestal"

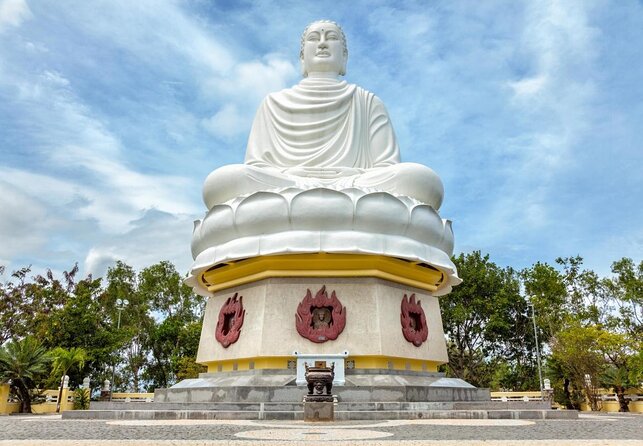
[440,252,643,411]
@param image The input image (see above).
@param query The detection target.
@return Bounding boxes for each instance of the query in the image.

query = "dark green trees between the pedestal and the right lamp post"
[440,251,537,389]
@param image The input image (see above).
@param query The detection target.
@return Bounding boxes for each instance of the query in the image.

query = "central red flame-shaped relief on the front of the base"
[295,285,346,343]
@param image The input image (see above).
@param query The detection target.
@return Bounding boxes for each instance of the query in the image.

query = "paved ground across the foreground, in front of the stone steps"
[0,414,643,446]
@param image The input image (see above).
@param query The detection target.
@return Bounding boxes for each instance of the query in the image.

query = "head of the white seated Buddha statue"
[299,20,348,77]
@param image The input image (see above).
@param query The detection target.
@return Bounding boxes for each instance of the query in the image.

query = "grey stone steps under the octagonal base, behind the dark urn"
[63,371,578,421]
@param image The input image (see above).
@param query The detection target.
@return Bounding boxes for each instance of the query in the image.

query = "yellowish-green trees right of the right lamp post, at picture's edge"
[522,257,643,411]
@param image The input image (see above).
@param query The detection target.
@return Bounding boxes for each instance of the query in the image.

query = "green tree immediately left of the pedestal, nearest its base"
[104,262,203,389]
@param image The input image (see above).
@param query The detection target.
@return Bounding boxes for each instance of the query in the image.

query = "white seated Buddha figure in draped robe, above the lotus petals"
[203,21,443,210]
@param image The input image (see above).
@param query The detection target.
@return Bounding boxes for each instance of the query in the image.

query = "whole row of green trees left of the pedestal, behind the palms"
[0,262,204,391]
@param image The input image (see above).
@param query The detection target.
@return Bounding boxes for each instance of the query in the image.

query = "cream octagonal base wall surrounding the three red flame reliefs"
[197,277,448,373]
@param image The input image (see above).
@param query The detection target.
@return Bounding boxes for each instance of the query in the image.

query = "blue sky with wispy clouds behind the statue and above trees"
[0,0,643,275]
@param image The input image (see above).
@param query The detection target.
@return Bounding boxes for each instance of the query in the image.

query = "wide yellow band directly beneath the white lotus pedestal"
[199,253,445,293]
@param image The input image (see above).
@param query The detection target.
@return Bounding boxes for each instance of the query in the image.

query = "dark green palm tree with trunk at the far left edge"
[0,337,50,413]
